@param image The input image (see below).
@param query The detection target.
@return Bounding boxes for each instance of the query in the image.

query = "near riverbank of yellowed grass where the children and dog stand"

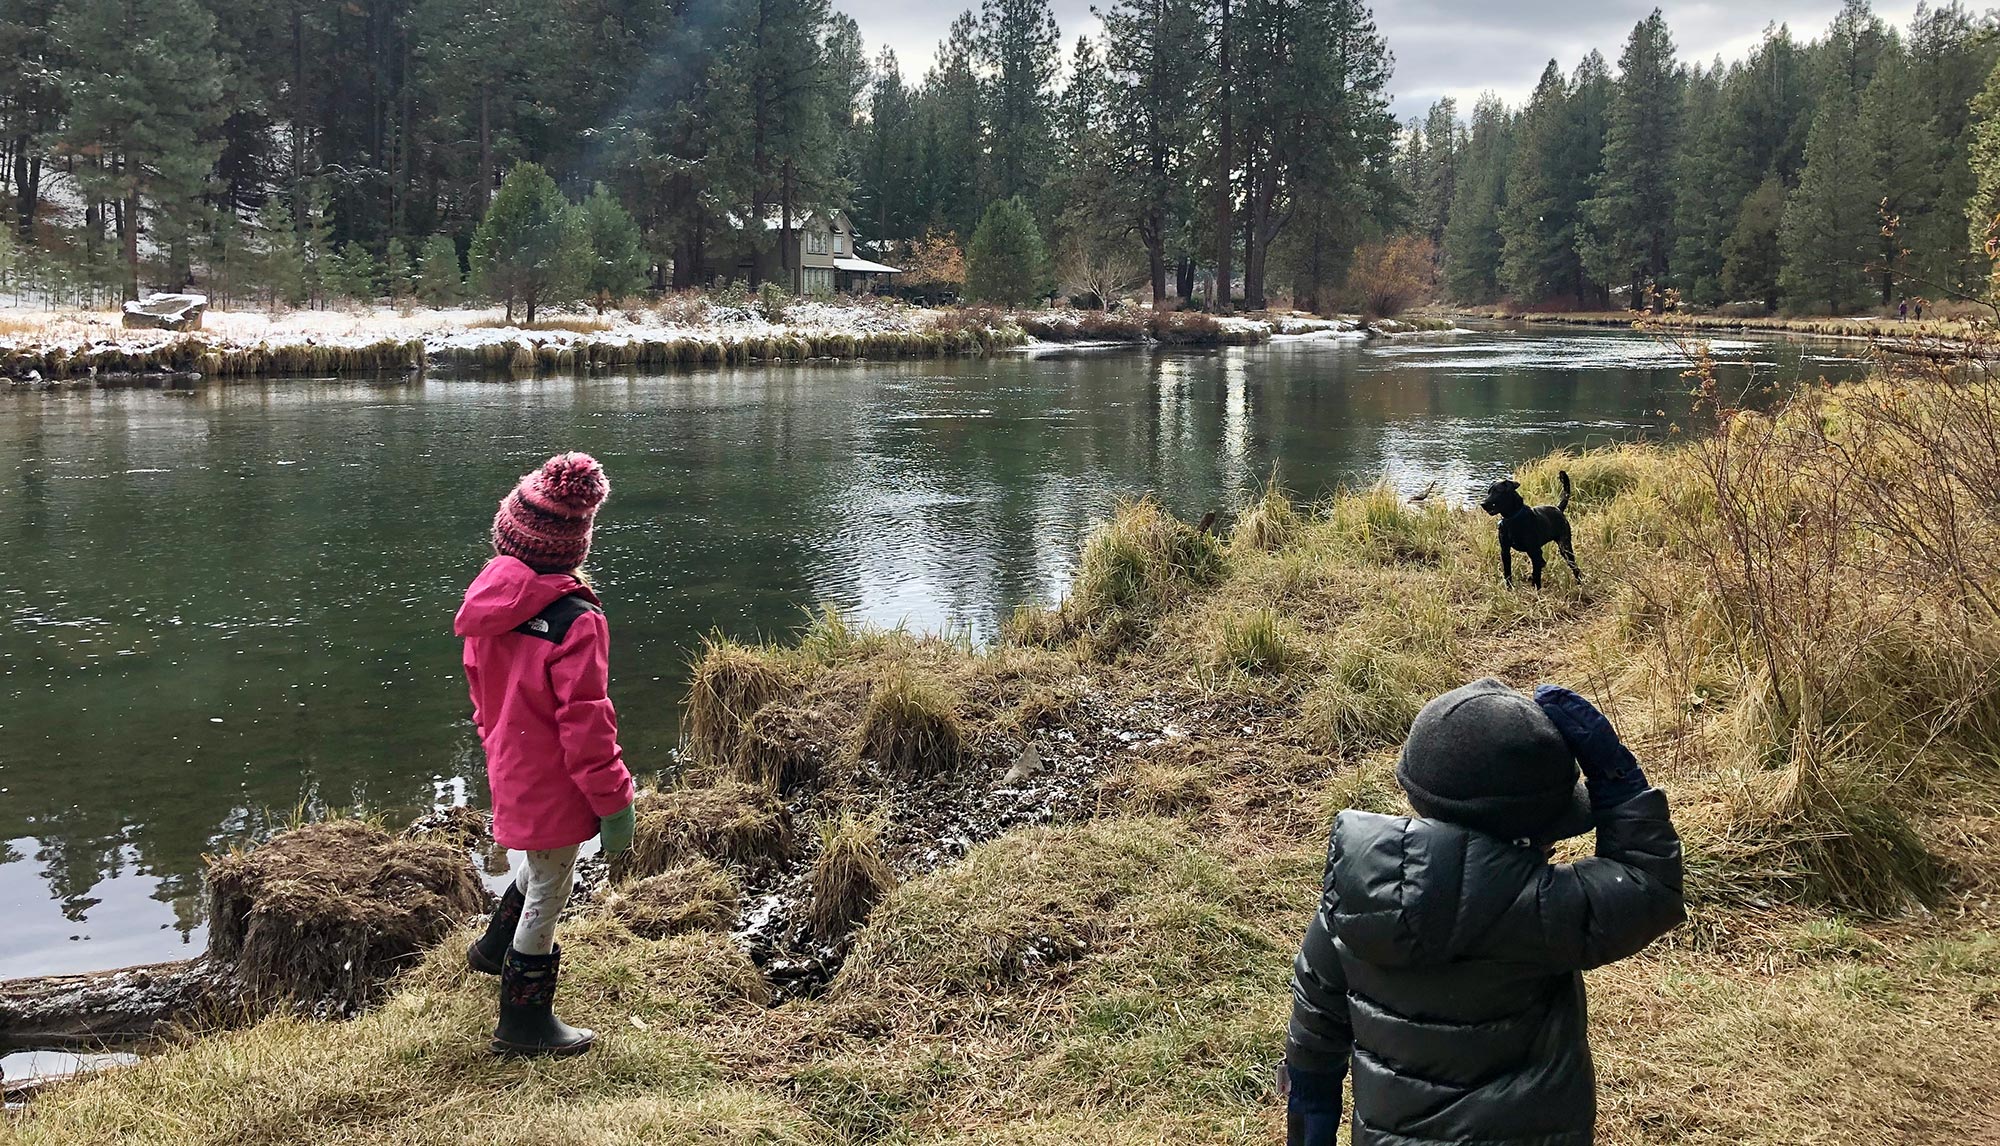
[0,362,2000,1146]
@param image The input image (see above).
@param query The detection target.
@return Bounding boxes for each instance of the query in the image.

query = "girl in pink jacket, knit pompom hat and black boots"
[454,454,632,1054]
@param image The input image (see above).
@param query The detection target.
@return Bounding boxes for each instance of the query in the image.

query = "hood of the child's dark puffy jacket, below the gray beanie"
[1332,810,1548,966]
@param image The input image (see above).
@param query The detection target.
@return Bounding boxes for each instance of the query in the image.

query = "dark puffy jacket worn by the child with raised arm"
[1286,788,1684,1146]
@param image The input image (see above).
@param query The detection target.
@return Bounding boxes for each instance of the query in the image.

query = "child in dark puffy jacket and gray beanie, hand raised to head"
[1284,678,1684,1146]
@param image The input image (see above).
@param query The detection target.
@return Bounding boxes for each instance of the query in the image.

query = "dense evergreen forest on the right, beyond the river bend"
[1396,0,2000,314]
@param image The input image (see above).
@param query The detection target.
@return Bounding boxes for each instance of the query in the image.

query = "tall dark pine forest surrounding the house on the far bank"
[0,0,1402,306]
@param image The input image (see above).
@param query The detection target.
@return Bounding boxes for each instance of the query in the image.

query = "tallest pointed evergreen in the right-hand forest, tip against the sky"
[1582,8,1680,306]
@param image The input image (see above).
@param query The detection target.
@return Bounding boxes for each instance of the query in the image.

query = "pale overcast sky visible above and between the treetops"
[834,0,1912,118]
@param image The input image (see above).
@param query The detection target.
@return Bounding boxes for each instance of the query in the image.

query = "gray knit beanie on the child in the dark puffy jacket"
[1396,676,1594,844]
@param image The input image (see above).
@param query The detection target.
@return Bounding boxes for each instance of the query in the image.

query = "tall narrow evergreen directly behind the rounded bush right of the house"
[974,0,1060,200]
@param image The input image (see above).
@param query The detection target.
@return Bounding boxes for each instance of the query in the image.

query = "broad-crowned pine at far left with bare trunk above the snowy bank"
[52,0,222,298]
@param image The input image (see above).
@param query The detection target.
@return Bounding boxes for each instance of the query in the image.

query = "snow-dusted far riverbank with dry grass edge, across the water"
[0,296,1416,386]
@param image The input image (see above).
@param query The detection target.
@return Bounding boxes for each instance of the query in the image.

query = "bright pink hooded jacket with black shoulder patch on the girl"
[452,556,632,852]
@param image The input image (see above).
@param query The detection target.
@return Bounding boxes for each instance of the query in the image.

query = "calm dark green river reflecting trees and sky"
[0,330,1858,978]
